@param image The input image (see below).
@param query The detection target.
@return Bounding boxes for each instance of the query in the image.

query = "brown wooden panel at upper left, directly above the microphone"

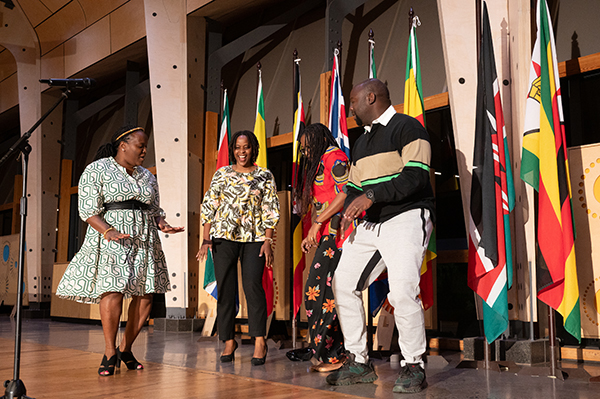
[65,16,110,76]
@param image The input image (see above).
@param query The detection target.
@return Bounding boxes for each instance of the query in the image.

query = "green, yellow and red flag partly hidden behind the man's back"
[404,16,437,310]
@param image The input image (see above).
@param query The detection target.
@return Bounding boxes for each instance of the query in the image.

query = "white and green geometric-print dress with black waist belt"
[56,157,170,303]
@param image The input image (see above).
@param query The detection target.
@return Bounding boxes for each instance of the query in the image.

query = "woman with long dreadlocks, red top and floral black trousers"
[288,123,350,372]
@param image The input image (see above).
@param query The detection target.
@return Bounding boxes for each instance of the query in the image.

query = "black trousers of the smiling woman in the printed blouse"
[212,238,267,341]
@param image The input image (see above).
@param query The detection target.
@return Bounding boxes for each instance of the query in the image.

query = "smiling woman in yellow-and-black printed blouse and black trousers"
[197,130,279,365]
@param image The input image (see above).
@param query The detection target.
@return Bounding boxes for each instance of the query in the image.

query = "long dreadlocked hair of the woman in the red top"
[293,123,339,215]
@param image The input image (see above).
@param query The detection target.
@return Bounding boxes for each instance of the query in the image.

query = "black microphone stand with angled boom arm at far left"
[0,87,71,399]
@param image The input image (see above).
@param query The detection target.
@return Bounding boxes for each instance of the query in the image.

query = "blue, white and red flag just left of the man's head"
[329,49,350,158]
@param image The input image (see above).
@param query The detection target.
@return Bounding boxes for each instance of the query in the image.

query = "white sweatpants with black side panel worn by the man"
[333,209,433,363]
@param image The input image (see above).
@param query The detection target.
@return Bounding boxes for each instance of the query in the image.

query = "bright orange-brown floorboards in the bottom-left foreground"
[0,338,358,399]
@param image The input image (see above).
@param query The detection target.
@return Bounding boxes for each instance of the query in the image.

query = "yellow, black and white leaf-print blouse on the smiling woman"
[201,165,279,242]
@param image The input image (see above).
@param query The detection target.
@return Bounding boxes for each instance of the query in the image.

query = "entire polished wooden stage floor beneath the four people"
[0,315,600,399]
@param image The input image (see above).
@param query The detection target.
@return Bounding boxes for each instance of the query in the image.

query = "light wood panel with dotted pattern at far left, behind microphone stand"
[0,234,29,306]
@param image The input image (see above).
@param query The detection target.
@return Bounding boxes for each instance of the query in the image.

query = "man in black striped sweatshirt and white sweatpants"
[327,79,435,393]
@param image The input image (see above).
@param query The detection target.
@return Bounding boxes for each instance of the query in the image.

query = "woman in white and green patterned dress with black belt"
[56,126,183,376]
